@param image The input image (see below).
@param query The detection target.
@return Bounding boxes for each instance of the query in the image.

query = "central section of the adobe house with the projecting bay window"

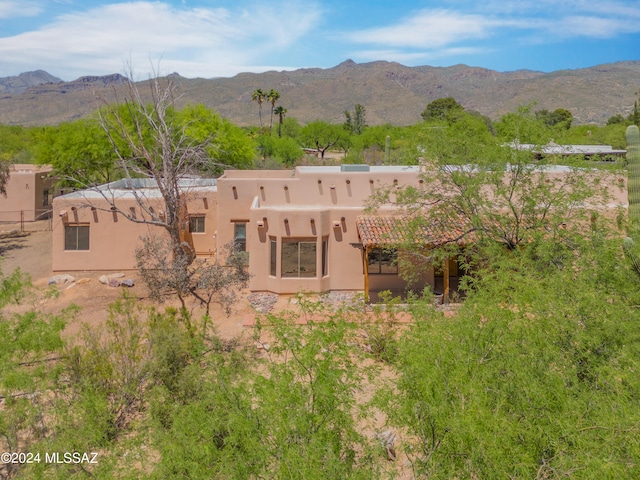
[217,165,434,300]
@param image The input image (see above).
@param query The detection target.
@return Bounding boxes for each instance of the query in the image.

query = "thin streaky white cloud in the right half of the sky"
[345,0,640,53]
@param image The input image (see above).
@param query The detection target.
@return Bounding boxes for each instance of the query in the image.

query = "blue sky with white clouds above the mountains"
[0,0,640,80]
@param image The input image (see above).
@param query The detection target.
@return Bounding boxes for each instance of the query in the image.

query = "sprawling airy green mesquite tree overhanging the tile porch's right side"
[370,109,615,288]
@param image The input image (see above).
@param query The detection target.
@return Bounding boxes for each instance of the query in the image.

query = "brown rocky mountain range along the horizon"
[0,60,640,125]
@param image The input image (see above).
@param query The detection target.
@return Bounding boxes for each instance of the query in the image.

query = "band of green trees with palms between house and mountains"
[0,89,640,182]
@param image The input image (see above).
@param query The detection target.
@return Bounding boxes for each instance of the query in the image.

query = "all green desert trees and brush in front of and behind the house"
[0,84,640,479]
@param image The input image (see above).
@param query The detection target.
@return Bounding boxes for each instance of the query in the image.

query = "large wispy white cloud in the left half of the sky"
[0,1,319,79]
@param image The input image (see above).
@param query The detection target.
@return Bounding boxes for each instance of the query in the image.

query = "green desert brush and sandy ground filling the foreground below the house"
[0,211,640,479]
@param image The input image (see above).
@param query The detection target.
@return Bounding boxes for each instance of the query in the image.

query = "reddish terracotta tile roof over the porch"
[356,215,465,247]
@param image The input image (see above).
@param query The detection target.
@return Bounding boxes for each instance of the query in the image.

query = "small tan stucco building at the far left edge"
[0,163,55,222]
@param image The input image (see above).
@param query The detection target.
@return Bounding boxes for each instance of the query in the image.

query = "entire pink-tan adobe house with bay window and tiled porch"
[53,165,626,300]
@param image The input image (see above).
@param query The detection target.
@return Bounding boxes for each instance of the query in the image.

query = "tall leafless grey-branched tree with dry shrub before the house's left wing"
[99,75,248,316]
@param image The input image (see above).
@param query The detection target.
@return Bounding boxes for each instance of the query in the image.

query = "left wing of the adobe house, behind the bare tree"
[52,179,217,272]
